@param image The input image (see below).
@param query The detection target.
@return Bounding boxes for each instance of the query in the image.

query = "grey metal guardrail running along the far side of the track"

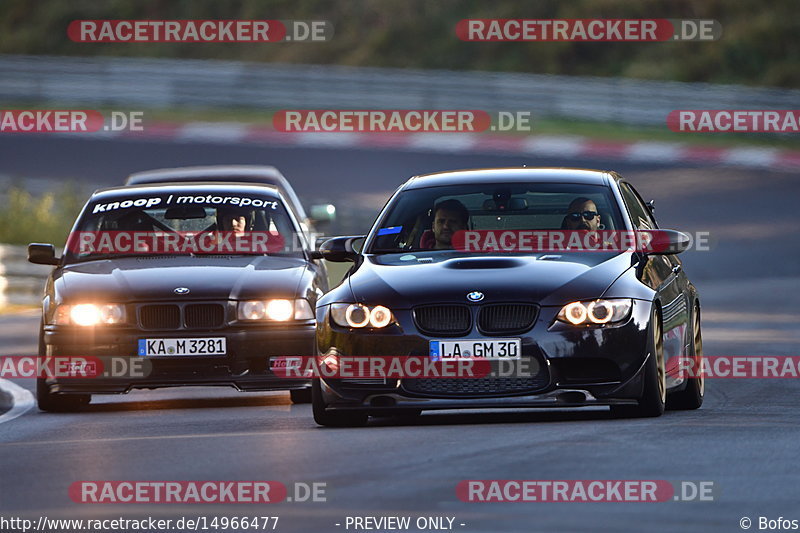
[0,55,800,125]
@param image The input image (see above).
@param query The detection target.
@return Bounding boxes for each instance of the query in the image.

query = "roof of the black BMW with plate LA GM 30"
[402,167,620,189]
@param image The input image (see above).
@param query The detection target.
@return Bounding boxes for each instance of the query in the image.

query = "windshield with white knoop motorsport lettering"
[65,190,303,262]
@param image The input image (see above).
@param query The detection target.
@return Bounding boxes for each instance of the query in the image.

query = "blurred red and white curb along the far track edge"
[31,122,800,170]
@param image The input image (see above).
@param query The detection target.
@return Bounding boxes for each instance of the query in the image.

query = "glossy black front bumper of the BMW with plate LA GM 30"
[317,300,651,411]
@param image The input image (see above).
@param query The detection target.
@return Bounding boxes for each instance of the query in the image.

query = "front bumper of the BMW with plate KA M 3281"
[44,323,314,394]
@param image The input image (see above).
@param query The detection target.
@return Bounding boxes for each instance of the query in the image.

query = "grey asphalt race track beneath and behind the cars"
[0,136,800,532]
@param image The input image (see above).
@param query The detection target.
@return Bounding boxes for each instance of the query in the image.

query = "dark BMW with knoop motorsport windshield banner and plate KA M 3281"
[28,182,328,411]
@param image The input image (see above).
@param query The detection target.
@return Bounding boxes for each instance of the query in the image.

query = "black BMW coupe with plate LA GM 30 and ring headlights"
[312,168,704,426]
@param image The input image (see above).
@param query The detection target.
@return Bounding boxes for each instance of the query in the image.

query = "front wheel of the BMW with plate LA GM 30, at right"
[611,308,667,418]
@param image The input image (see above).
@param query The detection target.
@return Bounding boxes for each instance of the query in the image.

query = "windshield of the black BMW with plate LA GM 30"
[367,182,624,253]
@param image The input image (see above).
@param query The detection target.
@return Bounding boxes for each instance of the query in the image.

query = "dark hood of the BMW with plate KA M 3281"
[55,256,306,302]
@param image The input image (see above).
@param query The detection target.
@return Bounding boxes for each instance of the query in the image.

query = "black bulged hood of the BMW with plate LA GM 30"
[350,252,633,309]
